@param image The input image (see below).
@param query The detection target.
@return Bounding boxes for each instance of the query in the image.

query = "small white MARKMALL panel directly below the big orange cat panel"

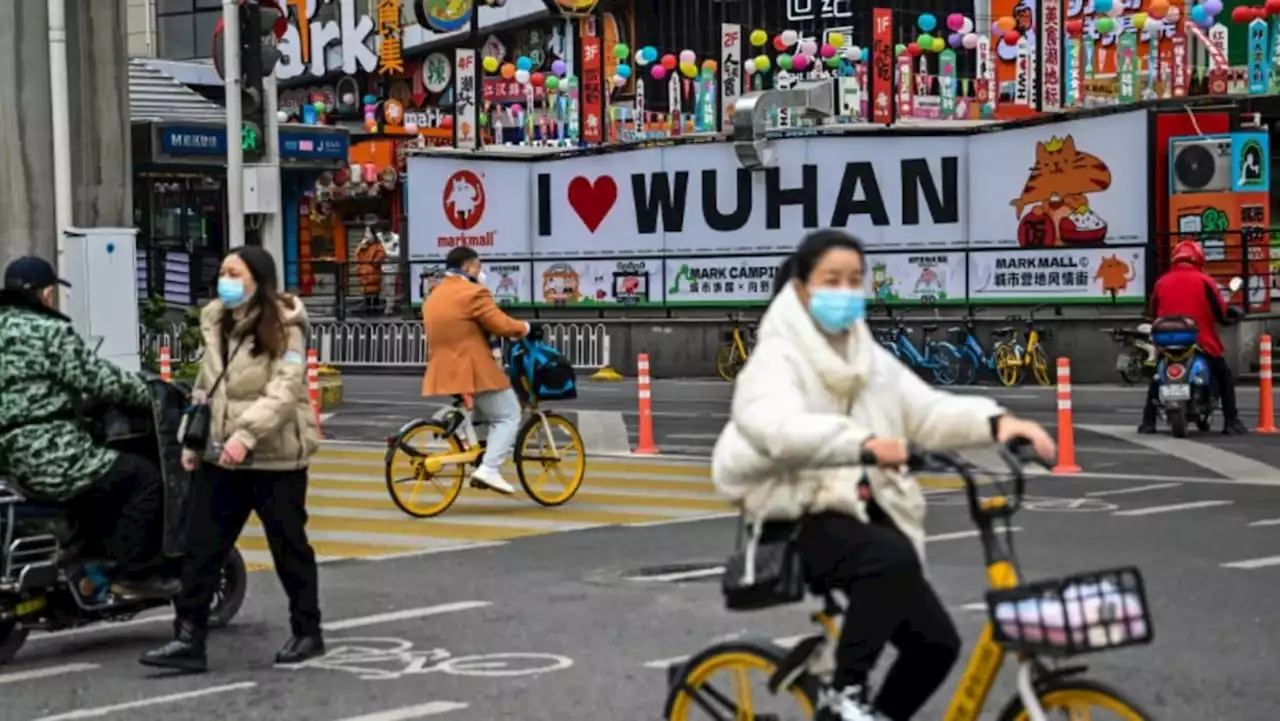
[969,247,1146,305]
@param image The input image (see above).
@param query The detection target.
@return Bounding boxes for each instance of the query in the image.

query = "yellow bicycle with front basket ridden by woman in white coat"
[663,448,1153,721]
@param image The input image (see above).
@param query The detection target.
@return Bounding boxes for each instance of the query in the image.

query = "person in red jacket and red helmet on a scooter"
[1138,241,1248,435]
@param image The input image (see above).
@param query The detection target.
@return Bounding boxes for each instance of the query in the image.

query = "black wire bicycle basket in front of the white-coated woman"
[987,566,1155,657]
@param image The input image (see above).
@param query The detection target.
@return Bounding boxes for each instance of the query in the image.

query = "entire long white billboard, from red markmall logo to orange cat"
[407,111,1149,305]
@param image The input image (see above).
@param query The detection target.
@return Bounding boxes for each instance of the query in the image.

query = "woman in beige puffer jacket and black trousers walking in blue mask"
[141,246,324,672]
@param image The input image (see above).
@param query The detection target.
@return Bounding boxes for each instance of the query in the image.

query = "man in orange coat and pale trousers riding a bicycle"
[422,246,529,493]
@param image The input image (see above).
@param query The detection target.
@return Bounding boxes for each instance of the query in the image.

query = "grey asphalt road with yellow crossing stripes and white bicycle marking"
[0,377,1280,721]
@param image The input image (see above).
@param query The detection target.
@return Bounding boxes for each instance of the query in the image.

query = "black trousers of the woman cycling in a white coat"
[796,512,960,721]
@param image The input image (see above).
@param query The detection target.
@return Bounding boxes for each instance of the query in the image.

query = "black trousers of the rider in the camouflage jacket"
[69,453,164,580]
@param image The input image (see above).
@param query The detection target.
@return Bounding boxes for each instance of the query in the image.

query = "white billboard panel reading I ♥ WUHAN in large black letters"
[532,136,969,255]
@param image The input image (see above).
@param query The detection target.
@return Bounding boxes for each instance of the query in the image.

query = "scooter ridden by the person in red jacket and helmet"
[1151,278,1244,438]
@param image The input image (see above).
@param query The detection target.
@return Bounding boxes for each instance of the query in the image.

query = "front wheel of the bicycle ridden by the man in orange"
[513,412,586,506]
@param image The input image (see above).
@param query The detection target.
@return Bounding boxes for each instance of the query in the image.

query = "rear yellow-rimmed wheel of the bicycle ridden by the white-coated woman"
[663,639,818,721]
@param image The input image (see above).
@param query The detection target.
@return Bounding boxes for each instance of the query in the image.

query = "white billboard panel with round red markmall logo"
[406,158,530,261]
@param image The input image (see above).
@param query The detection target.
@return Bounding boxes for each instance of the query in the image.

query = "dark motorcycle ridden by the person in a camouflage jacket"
[0,380,248,665]
